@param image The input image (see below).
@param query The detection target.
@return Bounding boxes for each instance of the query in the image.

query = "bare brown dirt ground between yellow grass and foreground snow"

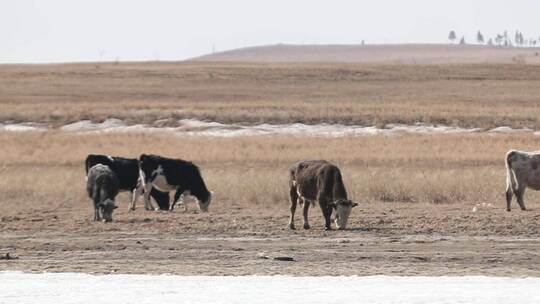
[0,195,540,276]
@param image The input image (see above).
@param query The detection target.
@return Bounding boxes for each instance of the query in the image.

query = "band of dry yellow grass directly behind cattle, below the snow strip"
[0,132,539,214]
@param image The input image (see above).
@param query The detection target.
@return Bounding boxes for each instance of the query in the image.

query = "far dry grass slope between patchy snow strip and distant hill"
[0,63,540,128]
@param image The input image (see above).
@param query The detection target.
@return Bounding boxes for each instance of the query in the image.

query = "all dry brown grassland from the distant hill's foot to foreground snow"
[0,63,540,276]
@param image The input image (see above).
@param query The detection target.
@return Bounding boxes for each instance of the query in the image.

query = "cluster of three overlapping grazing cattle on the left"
[85,154,212,222]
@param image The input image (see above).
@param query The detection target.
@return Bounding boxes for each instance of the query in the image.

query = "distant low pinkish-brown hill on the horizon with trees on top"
[191,44,540,64]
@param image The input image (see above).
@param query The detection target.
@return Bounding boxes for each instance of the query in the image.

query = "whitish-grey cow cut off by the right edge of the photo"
[506,150,540,211]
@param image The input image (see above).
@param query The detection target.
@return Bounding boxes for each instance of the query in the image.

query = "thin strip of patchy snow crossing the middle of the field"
[0,118,540,137]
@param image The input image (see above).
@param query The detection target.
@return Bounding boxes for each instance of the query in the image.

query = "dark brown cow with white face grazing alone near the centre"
[289,160,358,230]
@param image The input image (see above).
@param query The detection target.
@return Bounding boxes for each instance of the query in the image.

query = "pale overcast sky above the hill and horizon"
[0,0,540,63]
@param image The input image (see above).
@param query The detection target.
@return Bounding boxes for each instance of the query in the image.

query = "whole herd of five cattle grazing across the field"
[85,150,540,230]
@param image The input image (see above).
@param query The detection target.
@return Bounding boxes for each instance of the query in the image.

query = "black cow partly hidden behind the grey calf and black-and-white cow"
[85,154,170,210]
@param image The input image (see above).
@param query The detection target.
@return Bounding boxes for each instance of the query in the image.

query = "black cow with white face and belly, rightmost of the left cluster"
[139,154,212,212]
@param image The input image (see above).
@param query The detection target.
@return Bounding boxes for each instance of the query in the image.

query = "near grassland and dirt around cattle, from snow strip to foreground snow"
[0,132,540,276]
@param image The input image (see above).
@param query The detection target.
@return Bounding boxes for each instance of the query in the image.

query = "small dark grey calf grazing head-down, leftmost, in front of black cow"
[86,164,119,222]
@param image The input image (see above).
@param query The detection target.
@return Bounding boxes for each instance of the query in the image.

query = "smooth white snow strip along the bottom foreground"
[0,272,540,304]
